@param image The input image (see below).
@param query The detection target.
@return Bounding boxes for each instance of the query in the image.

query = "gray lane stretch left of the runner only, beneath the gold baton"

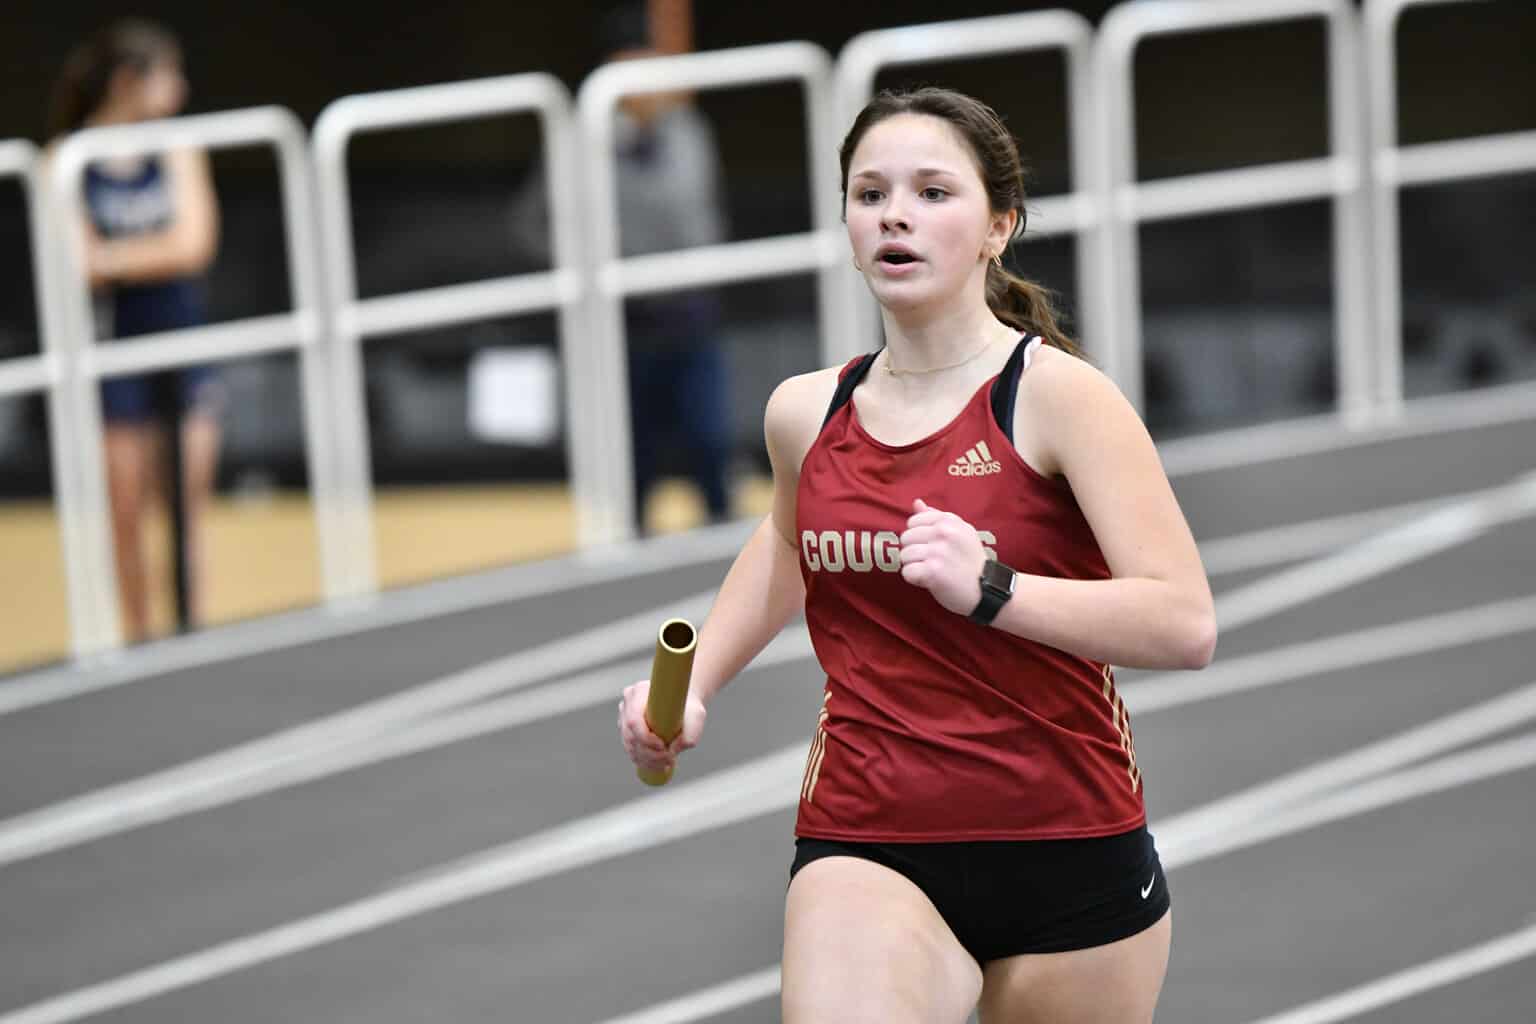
[0,660,822,1010]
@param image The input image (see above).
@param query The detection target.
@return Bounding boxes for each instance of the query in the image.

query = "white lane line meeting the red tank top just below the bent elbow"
[1120,597,1536,715]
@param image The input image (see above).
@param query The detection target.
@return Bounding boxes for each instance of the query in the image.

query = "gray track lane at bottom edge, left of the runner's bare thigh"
[92,814,793,1024]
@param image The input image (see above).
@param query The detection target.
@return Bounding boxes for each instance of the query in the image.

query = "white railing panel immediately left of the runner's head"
[578,43,857,539]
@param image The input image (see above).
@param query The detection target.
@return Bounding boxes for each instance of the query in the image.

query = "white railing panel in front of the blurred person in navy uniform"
[45,107,344,654]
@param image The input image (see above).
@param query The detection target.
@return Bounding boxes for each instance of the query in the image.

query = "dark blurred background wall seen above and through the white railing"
[0,0,1536,490]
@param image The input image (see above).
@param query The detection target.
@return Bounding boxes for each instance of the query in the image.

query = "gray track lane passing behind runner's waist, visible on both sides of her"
[0,620,1536,1006]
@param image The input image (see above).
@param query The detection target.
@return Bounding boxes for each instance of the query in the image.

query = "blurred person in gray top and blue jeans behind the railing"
[511,0,731,534]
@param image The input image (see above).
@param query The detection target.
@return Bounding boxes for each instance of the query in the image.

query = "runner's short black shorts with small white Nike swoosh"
[790,827,1170,966]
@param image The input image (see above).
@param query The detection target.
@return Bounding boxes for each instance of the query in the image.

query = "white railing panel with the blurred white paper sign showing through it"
[315,72,589,593]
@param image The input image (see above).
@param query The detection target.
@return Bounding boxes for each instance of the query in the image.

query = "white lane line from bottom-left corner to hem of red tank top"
[0,746,805,1024]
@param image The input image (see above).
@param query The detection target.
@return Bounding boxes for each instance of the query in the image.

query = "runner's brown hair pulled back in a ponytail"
[837,86,1083,356]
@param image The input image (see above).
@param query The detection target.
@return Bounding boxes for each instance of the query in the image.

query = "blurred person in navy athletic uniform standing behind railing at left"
[49,18,223,642]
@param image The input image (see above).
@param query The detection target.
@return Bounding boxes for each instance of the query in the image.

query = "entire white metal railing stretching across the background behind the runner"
[24,0,1536,657]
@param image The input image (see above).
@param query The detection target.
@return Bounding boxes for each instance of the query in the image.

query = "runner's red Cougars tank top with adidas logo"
[796,342,1146,843]
